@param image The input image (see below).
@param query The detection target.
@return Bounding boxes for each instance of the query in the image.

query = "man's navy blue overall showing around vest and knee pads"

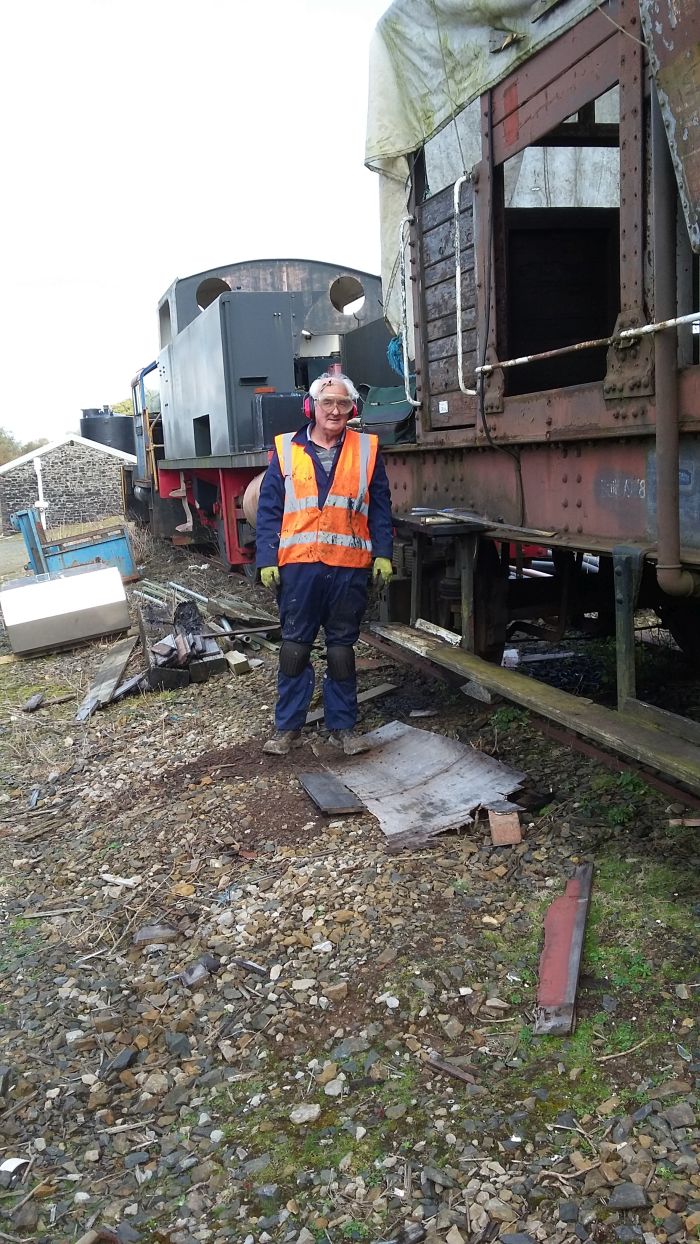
[256,427,393,731]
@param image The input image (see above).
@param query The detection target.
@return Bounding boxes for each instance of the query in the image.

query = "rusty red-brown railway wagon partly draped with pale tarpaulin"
[367,0,700,791]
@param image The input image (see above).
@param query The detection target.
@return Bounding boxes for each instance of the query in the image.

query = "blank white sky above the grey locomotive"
[0,0,388,440]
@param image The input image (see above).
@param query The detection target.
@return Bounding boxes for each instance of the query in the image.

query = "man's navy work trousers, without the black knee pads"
[275,562,369,730]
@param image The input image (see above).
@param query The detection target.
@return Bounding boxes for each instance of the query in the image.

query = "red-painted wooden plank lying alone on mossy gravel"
[533,863,593,1036]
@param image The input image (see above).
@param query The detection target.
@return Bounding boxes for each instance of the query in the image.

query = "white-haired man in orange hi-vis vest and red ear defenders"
[256,374,393,756]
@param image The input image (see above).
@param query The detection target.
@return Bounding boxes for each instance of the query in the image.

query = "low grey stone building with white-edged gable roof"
[0,434,136,535]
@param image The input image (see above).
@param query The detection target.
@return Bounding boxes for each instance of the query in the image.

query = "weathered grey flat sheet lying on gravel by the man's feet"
[326,722,525,851]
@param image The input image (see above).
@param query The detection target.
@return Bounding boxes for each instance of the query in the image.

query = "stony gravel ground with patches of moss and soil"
[0,542,700,1244]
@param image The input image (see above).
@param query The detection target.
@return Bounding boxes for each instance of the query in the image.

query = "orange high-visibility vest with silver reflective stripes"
[275,428,379,569]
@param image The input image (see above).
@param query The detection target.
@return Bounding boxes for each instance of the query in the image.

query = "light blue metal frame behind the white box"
[10,509,138,580]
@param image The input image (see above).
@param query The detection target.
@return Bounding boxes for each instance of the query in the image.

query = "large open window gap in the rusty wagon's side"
[496,87,619,394]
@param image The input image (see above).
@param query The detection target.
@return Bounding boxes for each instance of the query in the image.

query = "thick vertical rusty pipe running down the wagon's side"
[652,87,700,596]
